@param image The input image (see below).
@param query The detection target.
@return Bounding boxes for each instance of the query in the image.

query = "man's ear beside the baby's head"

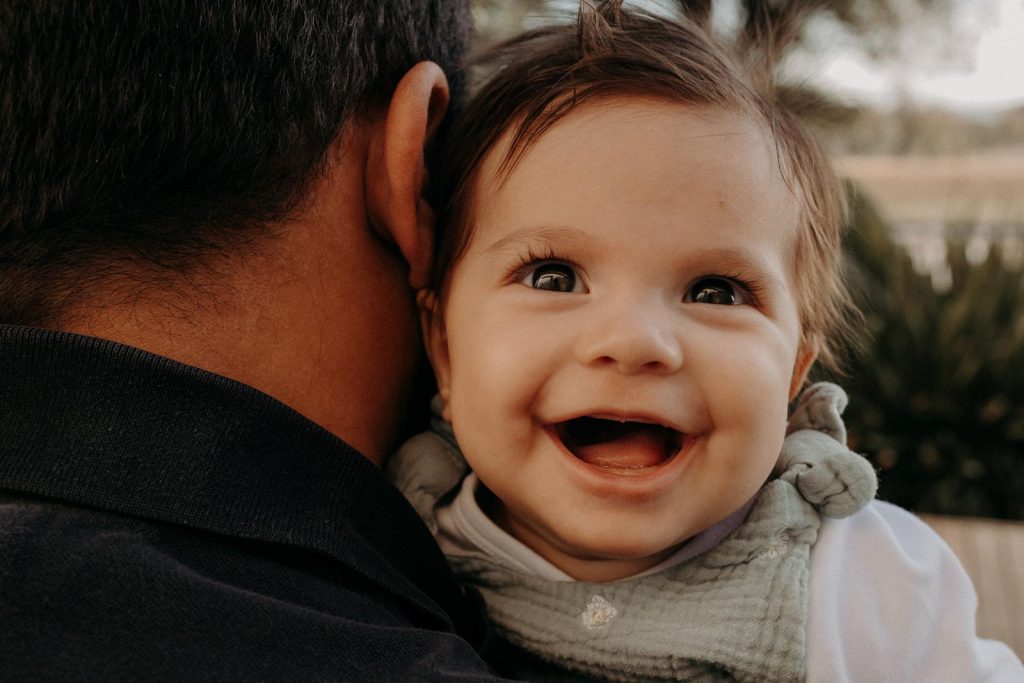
[366,61,449,289]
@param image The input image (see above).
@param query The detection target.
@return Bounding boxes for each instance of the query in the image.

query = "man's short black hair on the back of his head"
[0,0,469,325]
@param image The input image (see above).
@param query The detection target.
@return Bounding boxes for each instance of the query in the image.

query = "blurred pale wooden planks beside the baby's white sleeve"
[921,515,1024,658]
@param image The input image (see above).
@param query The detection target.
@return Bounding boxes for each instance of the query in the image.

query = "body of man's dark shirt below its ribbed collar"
[0,495,507,680]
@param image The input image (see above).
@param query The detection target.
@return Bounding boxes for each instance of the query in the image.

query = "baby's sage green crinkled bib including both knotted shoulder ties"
[388,384,876,681]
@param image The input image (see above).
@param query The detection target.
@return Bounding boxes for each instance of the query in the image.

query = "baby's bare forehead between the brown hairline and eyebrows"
[472,99,800,260]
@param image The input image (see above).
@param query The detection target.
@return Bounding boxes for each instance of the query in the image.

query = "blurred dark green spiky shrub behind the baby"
[838,188,1024,519]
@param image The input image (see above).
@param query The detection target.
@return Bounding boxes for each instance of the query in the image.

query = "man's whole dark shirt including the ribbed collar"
[0,326,503,681]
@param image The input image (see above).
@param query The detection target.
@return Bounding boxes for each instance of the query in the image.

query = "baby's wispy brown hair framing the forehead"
[431,0,856,370]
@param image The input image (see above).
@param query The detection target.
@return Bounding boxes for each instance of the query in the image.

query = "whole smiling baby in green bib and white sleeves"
[389,2,1021,681]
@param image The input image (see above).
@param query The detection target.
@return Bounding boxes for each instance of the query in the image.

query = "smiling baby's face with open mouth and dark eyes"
[431,99,813,581]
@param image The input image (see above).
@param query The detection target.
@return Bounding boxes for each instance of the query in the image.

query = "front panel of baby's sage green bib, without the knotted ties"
[450,480,820,681]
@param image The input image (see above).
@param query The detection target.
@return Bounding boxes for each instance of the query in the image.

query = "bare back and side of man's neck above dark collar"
[59,141,419,463]
